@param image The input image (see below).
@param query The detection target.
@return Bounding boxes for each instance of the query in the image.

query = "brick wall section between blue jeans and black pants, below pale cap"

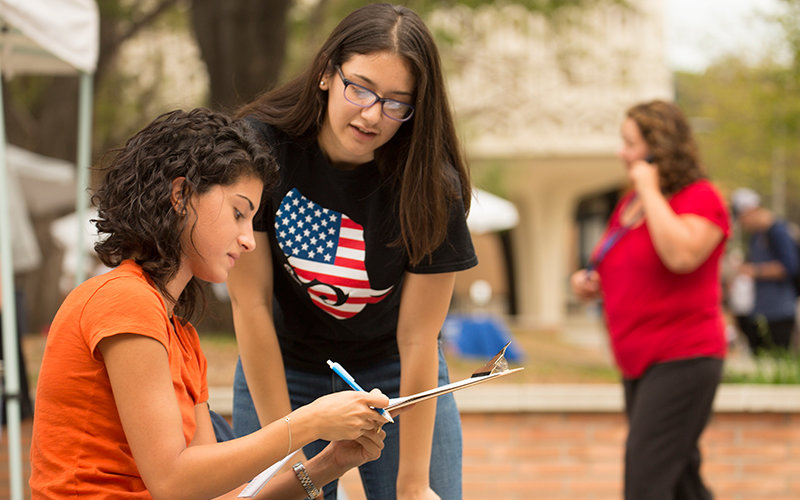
[462,413,625,500]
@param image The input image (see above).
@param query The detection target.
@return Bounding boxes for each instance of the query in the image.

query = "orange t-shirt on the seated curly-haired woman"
[30,261,208,500]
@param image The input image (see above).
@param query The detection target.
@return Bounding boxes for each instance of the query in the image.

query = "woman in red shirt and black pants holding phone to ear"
[571,101,729,500]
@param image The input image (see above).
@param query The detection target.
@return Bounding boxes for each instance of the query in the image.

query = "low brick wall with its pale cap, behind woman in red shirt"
[454,384,800,500]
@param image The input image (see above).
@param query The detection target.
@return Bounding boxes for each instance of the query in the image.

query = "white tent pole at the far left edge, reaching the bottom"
[0,73,22,500]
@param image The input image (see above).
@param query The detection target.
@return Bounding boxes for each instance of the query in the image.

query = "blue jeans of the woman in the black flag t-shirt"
[233,348,462,500]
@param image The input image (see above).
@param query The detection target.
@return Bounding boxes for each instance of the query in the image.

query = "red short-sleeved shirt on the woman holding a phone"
[595,180,730,378]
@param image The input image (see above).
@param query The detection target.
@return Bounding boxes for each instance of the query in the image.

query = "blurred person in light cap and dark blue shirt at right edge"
[731,188,800,354]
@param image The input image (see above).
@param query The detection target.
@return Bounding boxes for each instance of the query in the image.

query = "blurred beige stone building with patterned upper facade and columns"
[432,0,673,328]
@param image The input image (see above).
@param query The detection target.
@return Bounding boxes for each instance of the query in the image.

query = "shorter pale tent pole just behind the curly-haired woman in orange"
[75,71,94,286]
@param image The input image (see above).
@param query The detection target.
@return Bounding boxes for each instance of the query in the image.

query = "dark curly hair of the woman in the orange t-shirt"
[92,108,277,321]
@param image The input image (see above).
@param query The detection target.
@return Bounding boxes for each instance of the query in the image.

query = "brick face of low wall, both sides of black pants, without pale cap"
[462,412,800,500]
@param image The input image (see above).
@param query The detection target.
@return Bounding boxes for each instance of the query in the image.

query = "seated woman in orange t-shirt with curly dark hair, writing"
[30,109,388,499]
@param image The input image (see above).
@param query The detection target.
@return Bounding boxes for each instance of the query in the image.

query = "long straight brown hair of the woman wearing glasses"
[237,3,472,264]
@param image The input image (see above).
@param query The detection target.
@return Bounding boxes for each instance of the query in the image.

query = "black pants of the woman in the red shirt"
[623,358,722,500]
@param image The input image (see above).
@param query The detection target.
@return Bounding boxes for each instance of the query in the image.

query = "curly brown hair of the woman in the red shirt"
[626,100,706,195]
